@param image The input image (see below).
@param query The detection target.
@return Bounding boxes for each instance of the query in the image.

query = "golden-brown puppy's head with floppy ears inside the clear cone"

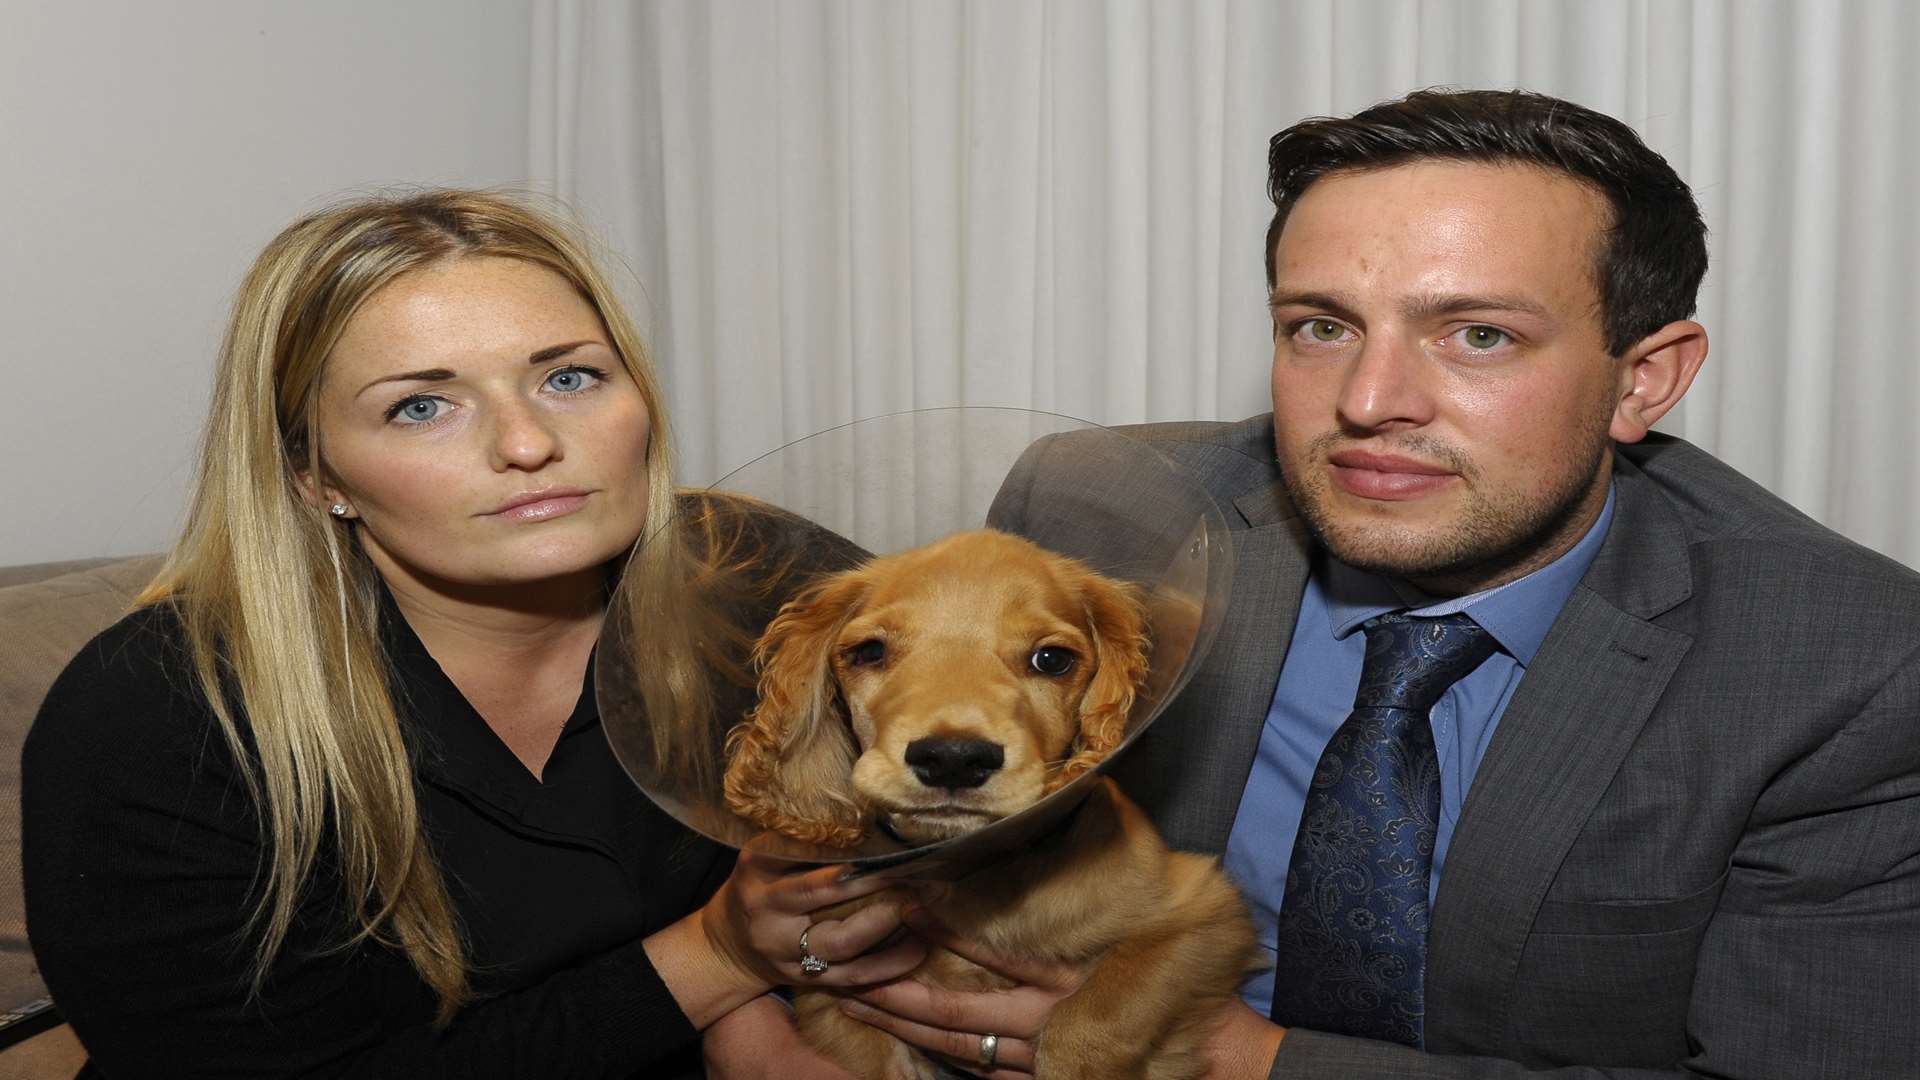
[726,530,1146,847]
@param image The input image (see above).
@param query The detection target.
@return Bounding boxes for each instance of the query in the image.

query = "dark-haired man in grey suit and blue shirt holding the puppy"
[852,92,1920,1080]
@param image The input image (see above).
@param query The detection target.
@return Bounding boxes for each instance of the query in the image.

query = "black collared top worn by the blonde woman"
[21,603,732,1078]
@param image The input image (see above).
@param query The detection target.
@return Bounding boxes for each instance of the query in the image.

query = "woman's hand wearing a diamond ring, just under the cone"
[647,851,927,1028]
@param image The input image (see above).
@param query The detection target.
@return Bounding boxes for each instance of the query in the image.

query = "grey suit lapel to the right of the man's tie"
[1427,455,1692,1051]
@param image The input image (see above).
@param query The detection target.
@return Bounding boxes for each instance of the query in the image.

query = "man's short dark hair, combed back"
[1267,90,1707,356]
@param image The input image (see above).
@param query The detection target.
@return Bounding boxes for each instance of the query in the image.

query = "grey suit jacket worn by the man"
[993,417,1920,1080]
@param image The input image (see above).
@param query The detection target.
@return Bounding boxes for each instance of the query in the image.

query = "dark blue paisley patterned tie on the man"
[1273,613,1496,1045]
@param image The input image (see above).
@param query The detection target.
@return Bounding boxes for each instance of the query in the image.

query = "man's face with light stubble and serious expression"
[1273,161,1630,594]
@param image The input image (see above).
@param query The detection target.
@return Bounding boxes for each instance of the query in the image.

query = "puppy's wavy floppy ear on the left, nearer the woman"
[724,571,868,847]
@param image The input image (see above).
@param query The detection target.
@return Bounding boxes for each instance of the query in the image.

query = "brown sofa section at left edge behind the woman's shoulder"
[0,555,159,1080]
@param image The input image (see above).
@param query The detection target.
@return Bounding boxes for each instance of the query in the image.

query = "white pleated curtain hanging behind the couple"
[530,0,1920,565]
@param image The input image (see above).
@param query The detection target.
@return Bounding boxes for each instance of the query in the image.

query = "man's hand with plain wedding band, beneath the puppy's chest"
[841,909,1087,1080]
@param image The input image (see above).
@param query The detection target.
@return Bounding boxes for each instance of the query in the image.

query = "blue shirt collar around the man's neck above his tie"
[1313,484,1615,667]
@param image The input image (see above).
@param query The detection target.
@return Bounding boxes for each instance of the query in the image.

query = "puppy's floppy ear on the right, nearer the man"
[1046,571,1146,792]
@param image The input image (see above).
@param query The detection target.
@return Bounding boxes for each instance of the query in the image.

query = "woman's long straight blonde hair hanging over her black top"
[140,190,674,1022]
